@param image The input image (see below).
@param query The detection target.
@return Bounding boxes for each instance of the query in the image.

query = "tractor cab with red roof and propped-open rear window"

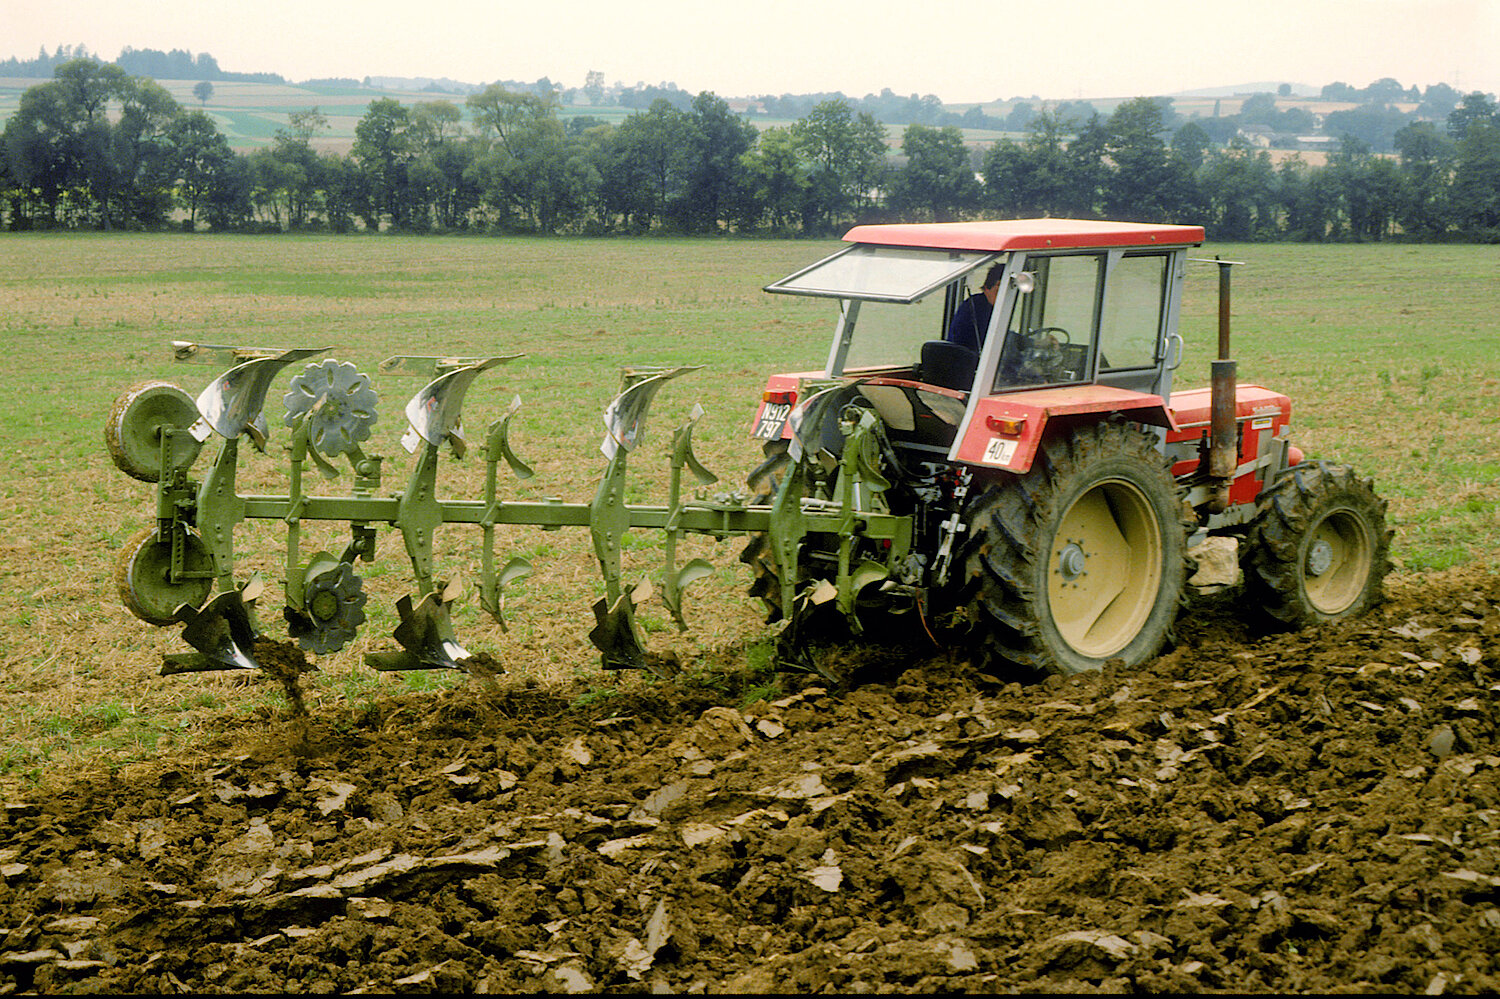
[755,219,1203,471]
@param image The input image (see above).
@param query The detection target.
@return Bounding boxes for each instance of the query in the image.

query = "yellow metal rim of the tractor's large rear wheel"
[1047,479,1163,659]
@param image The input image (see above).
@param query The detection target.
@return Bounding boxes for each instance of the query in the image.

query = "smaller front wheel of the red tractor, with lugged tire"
[1241,462,1392,630]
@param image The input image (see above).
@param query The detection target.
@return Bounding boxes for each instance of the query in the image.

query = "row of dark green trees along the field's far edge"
[0,59,1500,242]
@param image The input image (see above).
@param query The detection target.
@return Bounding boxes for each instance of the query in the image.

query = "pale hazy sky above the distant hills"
[11,0,1500,104]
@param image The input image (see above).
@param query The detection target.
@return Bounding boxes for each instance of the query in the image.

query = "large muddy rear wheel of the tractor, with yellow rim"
[965,423,1185,675]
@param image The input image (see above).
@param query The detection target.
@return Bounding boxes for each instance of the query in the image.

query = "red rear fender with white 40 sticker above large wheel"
[948,386,1176,474]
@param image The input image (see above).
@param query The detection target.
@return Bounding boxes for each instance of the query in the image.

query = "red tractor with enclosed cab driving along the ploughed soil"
[744,219,1389,674]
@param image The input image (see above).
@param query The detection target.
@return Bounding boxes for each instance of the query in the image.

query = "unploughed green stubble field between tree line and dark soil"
[0,234,1500,779]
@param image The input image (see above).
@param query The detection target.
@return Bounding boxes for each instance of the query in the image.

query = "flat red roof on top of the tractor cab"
[845,219,1203,252]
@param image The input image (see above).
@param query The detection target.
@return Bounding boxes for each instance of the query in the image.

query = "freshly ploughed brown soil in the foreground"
[0,570,1500,993]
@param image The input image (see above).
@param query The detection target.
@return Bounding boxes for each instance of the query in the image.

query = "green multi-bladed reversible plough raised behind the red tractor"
[105,342,911,675]
